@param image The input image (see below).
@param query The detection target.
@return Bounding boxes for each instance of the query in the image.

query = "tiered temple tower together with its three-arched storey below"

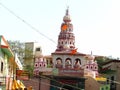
[52,8,85,69]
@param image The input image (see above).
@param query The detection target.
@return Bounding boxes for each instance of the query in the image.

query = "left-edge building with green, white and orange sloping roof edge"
[0,35,22,90]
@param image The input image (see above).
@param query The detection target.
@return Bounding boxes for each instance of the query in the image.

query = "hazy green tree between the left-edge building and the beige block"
[8,40,33,76]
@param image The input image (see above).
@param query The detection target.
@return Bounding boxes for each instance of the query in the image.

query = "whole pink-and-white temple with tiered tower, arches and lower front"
[30,8,109,90]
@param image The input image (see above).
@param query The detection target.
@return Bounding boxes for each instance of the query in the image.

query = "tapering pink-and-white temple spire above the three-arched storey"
[56,8,75,51]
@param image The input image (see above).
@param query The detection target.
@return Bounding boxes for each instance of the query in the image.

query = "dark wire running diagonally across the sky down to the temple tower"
[0,3,56,44]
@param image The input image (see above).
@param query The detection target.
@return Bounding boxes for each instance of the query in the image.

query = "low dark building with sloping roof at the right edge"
[102,60,120,90]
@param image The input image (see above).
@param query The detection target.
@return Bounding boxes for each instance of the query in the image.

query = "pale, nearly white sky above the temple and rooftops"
[0,0,120,58]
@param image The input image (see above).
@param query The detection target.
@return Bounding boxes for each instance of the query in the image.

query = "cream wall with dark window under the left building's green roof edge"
[0,48,13,90]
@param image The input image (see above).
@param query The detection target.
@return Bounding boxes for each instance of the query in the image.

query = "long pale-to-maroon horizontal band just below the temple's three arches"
[34,68,84,77]
